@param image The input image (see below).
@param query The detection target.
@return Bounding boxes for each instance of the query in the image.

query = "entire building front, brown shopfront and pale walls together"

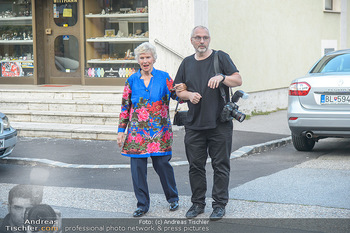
[0,0,350,111]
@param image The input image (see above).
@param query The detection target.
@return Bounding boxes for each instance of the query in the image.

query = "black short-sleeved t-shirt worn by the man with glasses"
[174,50,238,130]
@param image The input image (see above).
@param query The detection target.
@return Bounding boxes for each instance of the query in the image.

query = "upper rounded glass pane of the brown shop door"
[53,0,78,27]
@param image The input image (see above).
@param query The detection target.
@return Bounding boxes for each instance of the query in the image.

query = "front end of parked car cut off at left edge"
[0,112,17,158]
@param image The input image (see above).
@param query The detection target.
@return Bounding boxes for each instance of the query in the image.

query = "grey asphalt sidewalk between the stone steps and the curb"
[6,128,289,165]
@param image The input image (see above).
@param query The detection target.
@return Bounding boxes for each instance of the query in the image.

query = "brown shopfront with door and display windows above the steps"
[0,0,149,86]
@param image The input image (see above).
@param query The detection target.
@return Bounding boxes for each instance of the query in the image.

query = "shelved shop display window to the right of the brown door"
[85,0,149,78]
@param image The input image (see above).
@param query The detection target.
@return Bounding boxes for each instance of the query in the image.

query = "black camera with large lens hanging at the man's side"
[220,90,249,122]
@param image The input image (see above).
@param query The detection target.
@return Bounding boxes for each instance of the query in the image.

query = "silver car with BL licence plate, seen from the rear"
[288,49,350,151]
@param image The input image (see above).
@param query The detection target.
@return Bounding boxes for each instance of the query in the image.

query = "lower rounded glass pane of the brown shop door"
[55,35,79,73]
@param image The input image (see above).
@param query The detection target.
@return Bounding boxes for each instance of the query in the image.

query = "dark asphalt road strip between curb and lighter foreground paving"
[0,137,302,195]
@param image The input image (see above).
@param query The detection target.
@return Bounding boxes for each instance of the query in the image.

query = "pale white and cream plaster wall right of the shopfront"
[149,0,350,113]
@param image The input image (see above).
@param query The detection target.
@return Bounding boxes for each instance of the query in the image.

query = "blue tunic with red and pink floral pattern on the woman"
[118,68,176,158]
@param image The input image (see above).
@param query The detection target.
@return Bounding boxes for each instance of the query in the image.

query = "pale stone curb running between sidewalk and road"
[0,136,292,169]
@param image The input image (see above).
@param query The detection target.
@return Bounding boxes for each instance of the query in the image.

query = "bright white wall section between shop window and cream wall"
[148,0,195,78]
